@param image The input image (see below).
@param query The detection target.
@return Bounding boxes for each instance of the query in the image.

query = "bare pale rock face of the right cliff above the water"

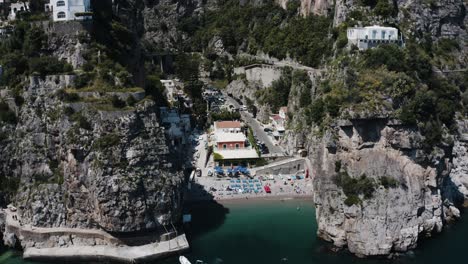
[309,119,466,256]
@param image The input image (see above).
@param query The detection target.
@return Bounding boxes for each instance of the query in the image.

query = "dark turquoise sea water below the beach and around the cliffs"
[0,201,468,264]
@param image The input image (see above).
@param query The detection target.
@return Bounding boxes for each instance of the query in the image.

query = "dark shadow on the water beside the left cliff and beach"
[184,183,229,240]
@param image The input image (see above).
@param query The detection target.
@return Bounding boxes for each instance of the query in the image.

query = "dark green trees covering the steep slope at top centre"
[179,0,332,67]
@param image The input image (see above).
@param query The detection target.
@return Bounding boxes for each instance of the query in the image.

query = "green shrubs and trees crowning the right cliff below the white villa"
[305,41,466,151]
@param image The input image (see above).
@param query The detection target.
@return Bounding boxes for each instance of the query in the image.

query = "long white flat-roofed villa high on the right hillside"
[347,26,404,50]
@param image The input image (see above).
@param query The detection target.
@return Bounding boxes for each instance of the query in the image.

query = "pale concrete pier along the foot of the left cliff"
[0,209,190,263]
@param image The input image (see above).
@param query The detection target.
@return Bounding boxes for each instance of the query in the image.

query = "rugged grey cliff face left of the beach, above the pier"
[1,76,183,232]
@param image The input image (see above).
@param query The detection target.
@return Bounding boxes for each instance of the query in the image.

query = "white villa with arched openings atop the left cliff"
[45,0,91,22]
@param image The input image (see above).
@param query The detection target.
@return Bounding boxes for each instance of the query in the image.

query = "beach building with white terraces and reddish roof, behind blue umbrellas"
[213,121,258,166]
